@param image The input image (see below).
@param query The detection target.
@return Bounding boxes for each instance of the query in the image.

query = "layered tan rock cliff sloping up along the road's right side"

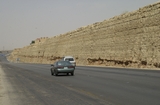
[8,3,160,68]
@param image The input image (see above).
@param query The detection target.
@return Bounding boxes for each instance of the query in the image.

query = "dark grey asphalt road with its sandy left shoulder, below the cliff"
[0,55,160,105]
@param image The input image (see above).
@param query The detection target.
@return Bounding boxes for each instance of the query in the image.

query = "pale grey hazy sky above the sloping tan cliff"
[0,0,158,50]
